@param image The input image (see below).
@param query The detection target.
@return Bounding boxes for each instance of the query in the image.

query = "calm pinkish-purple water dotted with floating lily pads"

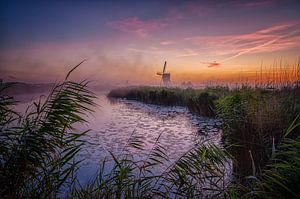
[13,93,225,182]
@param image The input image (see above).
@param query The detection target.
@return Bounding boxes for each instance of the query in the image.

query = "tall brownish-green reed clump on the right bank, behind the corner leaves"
[217,89,299,176]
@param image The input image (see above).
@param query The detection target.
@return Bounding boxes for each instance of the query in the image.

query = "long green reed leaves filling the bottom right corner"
[234,114,300,198]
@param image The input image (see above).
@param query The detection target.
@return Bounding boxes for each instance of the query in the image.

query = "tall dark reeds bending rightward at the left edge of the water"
[0,63,95,198]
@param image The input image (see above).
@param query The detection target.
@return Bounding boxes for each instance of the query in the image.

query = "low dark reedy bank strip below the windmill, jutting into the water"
[108,87,230,117]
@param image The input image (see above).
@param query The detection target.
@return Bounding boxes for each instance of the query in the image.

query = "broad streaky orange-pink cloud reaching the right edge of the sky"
[184,21,300,62]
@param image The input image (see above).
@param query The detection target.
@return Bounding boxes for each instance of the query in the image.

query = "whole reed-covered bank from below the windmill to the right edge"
[108,86,300,197]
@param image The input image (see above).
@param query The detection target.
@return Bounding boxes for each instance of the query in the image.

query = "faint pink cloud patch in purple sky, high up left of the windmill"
[107,17,167,37]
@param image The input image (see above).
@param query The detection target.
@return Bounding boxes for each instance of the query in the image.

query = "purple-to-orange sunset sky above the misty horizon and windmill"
[0,0,300,84]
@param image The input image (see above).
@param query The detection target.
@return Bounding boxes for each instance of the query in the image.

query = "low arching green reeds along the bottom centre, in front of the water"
[68,133,229,198]
